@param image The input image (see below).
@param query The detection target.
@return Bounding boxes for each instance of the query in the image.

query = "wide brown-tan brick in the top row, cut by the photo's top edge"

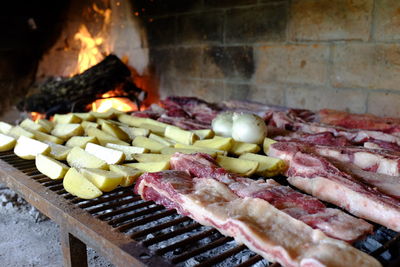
[289,0,379,40]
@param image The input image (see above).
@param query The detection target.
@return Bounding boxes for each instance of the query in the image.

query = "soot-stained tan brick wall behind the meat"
[133,0,400,116]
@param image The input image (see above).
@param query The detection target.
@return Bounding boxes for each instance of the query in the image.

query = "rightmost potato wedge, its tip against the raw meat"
[239,153,286,177]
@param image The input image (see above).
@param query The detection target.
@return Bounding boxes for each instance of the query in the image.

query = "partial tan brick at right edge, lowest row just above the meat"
[368,92,400,117]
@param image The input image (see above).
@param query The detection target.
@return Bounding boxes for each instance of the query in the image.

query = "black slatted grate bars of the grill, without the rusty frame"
[0,153,400,267]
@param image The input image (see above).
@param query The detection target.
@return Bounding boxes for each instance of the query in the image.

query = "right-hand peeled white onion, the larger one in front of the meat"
[232,113,267,144]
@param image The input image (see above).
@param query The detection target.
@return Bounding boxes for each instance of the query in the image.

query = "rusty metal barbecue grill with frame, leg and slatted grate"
[0,152,400,267]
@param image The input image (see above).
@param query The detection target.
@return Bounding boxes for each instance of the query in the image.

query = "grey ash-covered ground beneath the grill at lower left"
[0,184,113,267]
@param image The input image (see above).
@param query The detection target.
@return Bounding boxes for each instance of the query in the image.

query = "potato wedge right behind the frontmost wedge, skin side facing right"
[79,168,124,192]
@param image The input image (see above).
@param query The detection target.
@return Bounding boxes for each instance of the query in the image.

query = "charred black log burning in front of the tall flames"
[18,55,146,116]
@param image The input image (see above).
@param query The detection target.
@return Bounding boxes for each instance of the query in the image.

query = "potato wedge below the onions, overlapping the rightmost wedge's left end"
[216,155,259,176]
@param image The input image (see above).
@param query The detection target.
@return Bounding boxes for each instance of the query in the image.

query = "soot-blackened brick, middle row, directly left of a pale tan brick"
[202,46,254,80]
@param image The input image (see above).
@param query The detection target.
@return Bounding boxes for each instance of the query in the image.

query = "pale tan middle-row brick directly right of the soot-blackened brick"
[253,45,329,85]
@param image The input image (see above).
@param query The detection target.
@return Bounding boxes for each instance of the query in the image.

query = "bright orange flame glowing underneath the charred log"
[91,89,137,112]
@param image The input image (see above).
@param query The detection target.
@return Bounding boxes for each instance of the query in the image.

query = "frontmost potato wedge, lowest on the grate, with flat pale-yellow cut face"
[63,168,103,199]
